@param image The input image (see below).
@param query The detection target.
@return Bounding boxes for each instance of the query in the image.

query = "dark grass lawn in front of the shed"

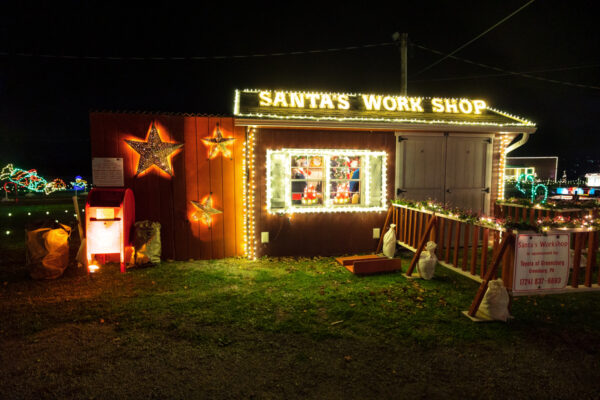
[0,203,600,399]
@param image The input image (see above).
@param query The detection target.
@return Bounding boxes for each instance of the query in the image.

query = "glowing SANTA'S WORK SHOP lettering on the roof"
[258,90,486,114]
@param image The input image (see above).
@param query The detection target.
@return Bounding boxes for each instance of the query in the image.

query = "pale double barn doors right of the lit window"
[396,133,492,213]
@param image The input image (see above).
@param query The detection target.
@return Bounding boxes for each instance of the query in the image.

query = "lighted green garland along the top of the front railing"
[392,199,600,233]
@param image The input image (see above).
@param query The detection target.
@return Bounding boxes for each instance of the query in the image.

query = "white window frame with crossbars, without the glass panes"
[265,148,388,214]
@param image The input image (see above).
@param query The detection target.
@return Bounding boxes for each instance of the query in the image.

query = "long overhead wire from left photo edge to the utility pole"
[0,42,395,61]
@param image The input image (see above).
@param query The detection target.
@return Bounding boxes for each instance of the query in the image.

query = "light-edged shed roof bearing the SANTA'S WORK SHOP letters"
[233,89,535,127]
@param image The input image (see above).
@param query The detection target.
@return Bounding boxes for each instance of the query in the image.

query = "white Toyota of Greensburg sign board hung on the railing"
[513,232,570,293]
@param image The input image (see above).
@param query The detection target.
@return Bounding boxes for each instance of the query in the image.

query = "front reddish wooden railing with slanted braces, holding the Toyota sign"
[377,204,600,316]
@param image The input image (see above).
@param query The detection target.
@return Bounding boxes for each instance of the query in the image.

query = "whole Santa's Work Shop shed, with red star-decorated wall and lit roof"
[90,90,536,260]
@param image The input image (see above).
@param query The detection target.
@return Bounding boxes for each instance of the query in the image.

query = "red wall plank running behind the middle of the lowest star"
[194,117,214,260]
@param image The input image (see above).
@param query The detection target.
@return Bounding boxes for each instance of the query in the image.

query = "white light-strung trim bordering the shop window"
[266,148,387,214]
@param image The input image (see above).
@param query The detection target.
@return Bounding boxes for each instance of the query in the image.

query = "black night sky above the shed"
[0,0,600,179]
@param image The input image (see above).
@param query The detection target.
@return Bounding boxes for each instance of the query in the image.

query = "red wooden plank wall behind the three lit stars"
[90,112,245,260]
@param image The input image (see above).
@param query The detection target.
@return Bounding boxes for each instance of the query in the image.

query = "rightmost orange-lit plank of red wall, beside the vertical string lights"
[219,118,237,257]
